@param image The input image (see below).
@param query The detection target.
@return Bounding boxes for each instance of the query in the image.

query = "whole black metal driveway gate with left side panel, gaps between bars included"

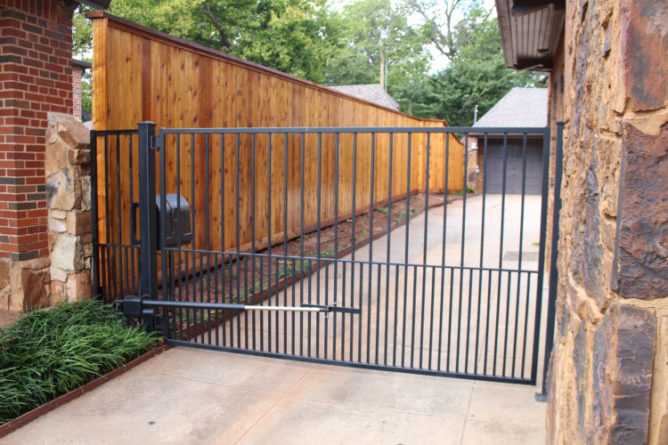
[92,123,562,384]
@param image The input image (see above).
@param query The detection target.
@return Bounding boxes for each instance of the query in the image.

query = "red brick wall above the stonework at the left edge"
[0,0,76,260]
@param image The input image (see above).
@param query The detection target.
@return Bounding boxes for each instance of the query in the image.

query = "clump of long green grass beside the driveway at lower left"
[0,300,159,424]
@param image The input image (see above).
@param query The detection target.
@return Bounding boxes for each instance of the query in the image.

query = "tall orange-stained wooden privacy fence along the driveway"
[88,13,465,298]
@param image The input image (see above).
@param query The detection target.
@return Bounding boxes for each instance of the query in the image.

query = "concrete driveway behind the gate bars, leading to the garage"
[209,195,546,379]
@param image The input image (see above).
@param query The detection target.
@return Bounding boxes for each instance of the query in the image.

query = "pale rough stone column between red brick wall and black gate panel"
[45,113,93,305]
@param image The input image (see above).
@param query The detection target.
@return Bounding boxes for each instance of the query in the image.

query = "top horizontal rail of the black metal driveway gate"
[160,127,550,136]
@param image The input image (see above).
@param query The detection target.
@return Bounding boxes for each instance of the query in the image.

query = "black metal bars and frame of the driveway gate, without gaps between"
[91,122,563,397]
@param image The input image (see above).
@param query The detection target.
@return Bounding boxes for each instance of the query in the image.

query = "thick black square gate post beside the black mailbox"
[138,122,158,299]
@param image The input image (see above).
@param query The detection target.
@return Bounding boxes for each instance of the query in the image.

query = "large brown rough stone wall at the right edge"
[547,0,668,444]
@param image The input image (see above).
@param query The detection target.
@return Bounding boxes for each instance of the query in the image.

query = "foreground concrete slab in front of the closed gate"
[5,348,545,445]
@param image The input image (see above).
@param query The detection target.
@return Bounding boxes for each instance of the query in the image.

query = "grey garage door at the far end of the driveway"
[484,144,543,194]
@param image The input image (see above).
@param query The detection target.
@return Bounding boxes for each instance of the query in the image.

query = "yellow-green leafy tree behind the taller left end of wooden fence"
[110,0,338,82]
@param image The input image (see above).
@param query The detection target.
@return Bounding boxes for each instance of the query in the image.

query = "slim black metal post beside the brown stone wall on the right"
[536,121,564,401]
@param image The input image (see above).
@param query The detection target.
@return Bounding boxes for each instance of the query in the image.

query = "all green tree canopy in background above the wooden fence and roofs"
[73,0,536,125]
